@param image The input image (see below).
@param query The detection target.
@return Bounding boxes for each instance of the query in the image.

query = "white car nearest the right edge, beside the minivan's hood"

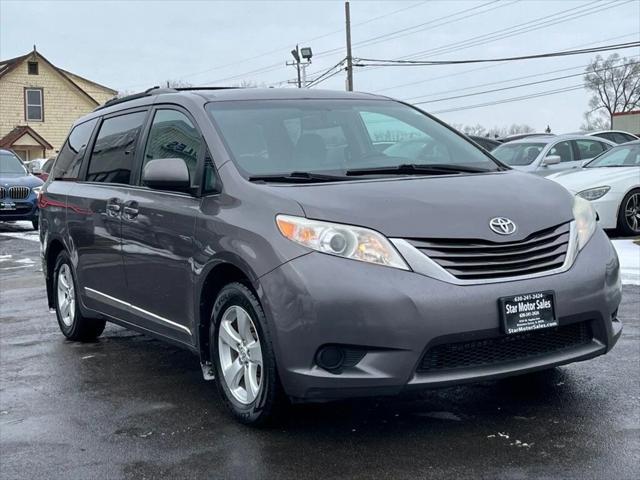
[547,140,640,235]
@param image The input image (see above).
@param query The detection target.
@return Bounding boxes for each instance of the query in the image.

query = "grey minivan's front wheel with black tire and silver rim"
[209,283,284,425]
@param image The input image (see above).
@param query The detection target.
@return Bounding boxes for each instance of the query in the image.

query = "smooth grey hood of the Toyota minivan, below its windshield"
[279,170,573,242]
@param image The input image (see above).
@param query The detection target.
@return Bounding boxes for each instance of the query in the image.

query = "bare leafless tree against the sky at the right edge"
[583,53,640,128]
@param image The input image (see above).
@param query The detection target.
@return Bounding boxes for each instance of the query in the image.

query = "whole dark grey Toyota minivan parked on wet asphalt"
[40,89,622,423]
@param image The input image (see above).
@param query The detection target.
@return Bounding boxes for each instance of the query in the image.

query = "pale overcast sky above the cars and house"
[0,0,640,133]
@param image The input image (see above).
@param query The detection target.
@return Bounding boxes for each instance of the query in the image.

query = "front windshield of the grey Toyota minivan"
[207,100,501,177]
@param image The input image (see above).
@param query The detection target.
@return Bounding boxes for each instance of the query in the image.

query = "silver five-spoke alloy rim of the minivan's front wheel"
[218,305,263,405]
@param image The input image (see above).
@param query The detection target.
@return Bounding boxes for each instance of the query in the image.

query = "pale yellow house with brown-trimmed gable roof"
[0,46,118,161]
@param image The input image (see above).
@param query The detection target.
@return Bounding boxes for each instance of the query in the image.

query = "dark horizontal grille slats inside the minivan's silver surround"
[407,223,570,280]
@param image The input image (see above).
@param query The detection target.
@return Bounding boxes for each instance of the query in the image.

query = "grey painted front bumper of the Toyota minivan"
[259,229,622,401]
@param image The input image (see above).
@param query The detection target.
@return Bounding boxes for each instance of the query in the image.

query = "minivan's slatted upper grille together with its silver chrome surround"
[391,222,578,285]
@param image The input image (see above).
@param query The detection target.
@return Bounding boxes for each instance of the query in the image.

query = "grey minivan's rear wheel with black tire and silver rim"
[53,251,106,342]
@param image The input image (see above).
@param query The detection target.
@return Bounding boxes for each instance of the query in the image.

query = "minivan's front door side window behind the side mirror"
[142,110,203,185]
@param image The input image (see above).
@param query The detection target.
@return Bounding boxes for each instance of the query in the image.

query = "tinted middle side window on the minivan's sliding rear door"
[87,112,147,184]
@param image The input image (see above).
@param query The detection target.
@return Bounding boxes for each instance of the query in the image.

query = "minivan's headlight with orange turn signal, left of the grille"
[276,215,409,270]
